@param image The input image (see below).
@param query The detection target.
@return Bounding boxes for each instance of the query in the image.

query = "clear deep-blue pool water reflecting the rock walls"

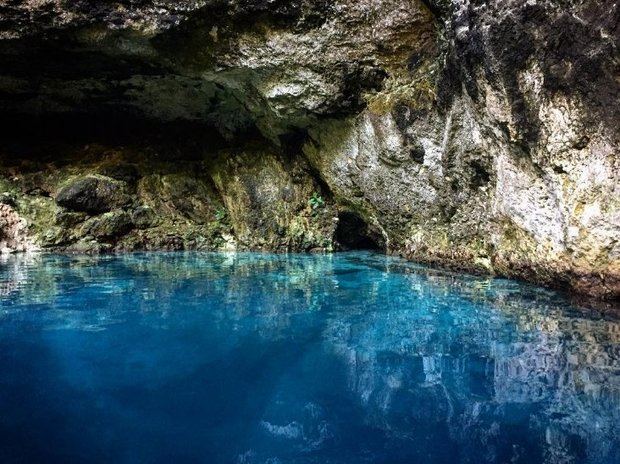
[0,253,620,464]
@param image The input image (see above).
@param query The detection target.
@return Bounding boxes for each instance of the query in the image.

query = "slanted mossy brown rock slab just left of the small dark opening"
[209,150,335,251]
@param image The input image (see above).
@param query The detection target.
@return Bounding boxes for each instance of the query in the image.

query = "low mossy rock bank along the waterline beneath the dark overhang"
[0,141,336,253]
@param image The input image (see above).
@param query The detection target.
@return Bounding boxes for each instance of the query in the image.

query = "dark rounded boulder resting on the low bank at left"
[56,175,130,214]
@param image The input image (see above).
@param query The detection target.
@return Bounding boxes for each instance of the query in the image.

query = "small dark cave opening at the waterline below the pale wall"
[336,210,386,252]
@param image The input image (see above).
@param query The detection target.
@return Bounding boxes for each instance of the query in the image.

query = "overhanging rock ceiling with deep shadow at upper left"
[0,0,436,141]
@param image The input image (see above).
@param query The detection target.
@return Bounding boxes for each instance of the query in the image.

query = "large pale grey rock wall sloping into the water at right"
[306,1,620,297]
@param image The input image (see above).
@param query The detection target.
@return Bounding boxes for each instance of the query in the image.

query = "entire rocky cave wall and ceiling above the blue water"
[0,0,620,299]
